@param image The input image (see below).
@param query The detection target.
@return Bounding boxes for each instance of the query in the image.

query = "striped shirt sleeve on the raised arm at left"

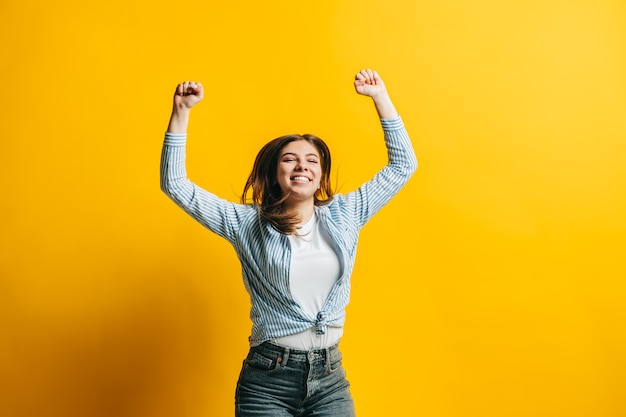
[161,132,253,243]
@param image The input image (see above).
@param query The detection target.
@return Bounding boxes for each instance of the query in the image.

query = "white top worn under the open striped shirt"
[273,213,343,350]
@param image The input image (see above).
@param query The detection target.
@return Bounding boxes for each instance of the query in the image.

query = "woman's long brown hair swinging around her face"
[241,134,334,234]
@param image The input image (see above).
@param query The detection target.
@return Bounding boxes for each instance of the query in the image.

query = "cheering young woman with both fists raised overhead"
[161,70,417,417]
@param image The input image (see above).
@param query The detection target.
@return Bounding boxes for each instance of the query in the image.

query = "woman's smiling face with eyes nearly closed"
[276,140,322,204]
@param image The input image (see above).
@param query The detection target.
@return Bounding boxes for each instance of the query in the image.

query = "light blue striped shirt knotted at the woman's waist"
[161,117,417,346]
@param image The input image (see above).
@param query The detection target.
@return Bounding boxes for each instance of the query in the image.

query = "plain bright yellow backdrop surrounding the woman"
[0,0,626,417]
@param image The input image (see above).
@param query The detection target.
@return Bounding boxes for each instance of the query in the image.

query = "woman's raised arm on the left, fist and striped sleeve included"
[161,81,244,243]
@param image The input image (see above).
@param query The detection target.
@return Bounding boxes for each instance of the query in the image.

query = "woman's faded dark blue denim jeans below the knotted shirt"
[235,342,354,417]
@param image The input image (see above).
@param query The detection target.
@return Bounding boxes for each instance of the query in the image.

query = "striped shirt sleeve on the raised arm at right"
[338,116,417,227]
